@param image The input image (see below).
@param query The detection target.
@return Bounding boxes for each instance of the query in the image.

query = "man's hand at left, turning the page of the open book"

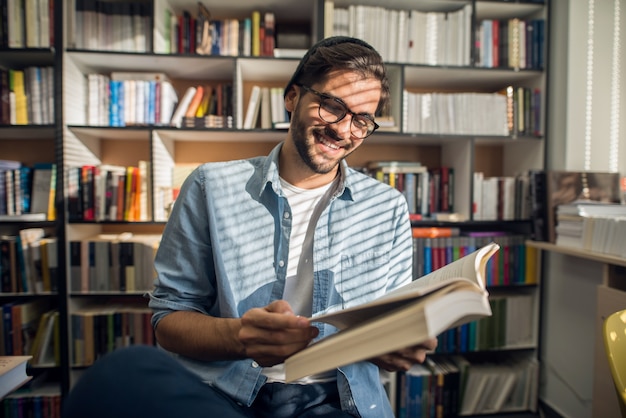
[239,300,319,367]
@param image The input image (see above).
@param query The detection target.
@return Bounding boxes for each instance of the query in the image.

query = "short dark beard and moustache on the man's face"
[291,112,356,174]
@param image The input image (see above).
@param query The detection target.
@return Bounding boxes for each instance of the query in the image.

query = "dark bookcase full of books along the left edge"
[0,1,69,416]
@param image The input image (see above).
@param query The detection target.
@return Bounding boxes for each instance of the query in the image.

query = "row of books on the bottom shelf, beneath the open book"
[397,355,539,418]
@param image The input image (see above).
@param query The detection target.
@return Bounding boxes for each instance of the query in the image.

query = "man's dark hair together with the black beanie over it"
[285,36,389,113]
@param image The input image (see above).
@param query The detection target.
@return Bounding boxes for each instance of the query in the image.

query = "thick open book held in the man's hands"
[285,243,500,382]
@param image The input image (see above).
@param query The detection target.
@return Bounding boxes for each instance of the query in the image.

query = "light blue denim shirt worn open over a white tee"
[150,144,412,418]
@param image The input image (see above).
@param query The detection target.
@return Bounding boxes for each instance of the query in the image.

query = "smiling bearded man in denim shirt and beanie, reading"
[62,37,436,418]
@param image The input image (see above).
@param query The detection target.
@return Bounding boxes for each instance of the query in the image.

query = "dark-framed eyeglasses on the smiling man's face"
[298,84,378,139]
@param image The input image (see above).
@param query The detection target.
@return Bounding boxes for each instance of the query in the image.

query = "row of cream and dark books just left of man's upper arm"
[69,233,161,293]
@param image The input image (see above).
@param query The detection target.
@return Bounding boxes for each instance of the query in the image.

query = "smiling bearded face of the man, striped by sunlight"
[291,71,381,174]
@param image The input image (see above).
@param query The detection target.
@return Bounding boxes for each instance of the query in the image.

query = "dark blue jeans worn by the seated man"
[63,346,352,418]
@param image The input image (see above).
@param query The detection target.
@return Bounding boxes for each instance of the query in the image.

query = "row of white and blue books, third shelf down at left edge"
[0,160,56,221]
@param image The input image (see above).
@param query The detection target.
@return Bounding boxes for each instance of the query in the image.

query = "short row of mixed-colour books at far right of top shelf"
[476,18,545,69]
